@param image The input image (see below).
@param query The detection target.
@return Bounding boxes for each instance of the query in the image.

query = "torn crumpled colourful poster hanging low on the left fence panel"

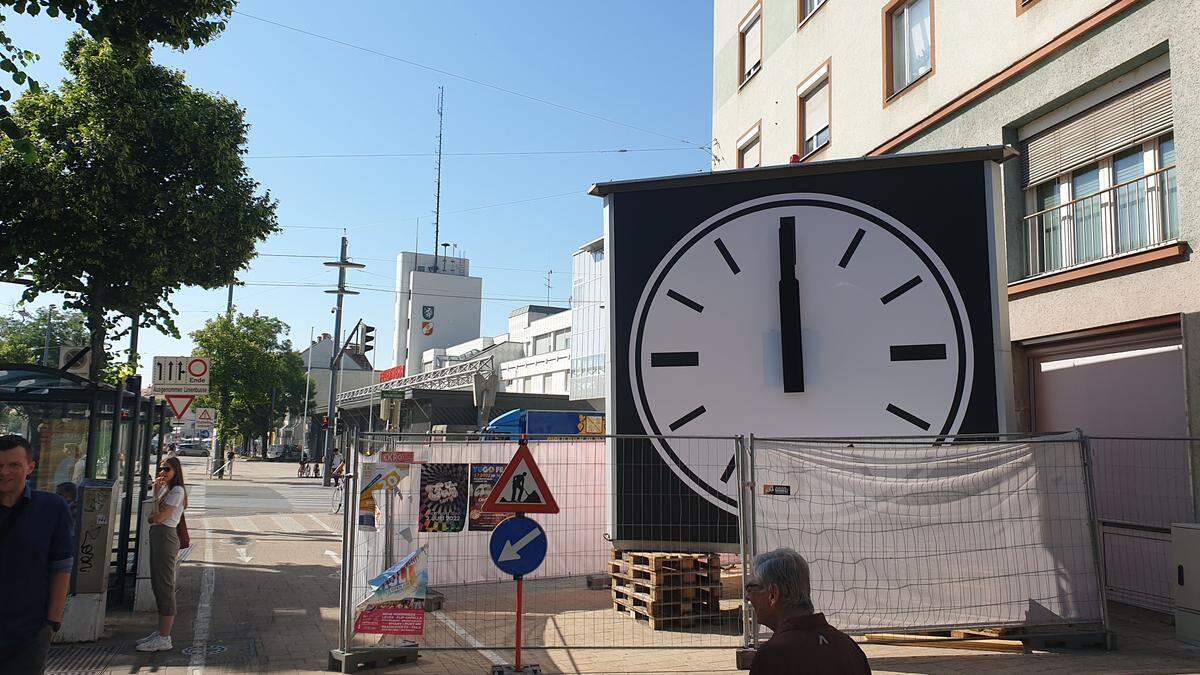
[354,546,428,635]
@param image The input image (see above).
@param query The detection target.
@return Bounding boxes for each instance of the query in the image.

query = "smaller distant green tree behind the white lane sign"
[191,312,312,458]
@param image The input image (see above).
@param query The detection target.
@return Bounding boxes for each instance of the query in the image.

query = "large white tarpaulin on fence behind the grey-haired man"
[754,436,1102,632]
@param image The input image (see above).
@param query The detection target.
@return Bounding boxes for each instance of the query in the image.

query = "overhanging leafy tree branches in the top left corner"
[0,0,236,151]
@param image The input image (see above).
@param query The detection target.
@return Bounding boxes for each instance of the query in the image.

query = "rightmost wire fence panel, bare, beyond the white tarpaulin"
[1088,437,1200,611]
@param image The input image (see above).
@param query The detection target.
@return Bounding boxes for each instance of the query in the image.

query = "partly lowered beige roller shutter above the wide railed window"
[1021,73,1172,186]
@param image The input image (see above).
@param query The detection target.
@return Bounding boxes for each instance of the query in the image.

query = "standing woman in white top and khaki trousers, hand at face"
[137,458,191,651]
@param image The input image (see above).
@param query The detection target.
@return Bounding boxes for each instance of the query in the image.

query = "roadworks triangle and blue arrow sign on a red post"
[482,438,558,673]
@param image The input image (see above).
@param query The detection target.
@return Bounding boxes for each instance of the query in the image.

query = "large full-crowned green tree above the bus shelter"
[0,35,276,380]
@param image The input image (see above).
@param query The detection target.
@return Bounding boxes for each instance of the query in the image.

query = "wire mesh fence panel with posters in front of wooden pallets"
[350,435,744,650]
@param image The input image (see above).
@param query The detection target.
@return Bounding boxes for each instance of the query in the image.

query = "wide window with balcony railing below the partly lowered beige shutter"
[1022,128,1180,277]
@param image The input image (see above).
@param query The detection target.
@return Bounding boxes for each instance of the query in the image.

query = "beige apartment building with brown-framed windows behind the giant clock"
[713,0,1200,609]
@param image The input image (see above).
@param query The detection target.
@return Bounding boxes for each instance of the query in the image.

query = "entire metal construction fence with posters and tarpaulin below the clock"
[321,425,1192,658]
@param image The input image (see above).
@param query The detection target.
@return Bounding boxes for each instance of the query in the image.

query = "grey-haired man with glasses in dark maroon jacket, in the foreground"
[746,549,871,675]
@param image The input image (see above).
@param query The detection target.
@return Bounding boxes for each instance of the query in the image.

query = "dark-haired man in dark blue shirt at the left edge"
[0,435,74,675]
